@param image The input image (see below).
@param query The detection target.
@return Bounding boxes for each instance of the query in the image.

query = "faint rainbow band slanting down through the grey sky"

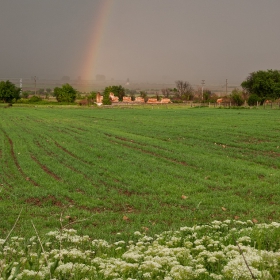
[82,0,114,80]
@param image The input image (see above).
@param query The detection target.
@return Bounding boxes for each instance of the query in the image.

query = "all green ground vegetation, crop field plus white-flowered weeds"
[0,105,280,279]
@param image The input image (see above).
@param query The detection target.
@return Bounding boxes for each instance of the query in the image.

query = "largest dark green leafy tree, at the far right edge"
[241,70,280,104]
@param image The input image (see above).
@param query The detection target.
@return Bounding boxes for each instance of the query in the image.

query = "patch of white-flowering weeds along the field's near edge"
[0,220,280,280]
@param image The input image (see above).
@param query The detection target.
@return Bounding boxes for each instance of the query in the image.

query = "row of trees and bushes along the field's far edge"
[0,70,280,106]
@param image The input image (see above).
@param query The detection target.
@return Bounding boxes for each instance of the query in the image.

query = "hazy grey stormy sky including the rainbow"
[0,0,280,85]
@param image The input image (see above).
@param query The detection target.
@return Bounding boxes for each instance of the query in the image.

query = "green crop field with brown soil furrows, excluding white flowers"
[0,105,280,240]
